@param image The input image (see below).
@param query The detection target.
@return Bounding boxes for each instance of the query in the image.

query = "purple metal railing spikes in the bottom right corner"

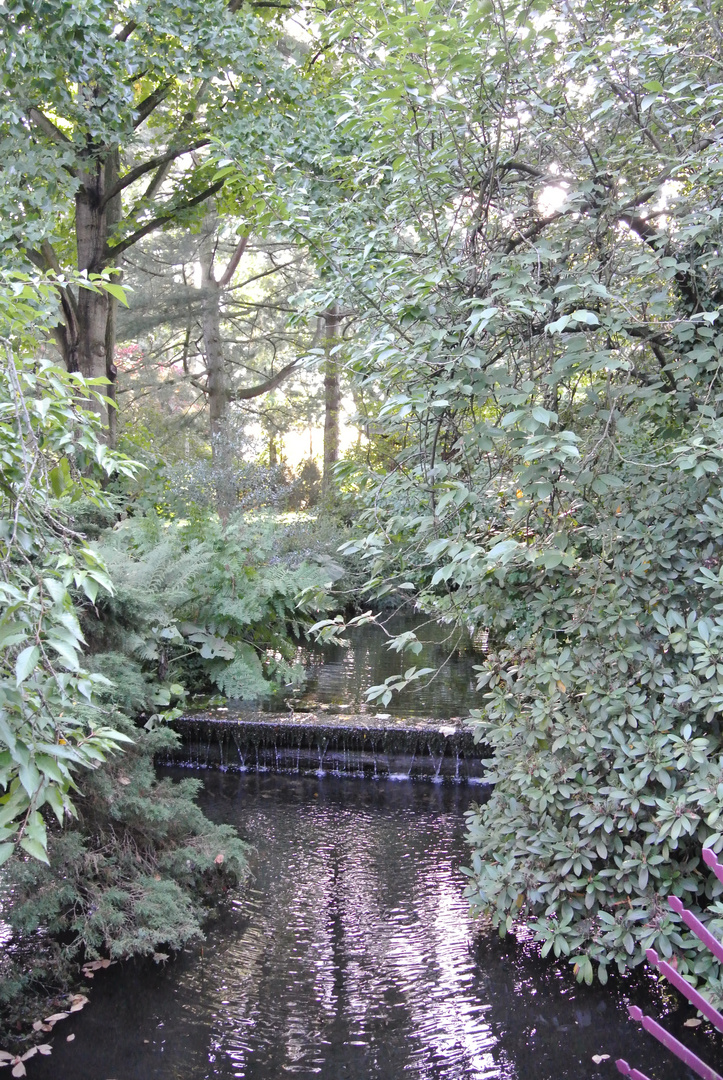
[615,848,723,1080]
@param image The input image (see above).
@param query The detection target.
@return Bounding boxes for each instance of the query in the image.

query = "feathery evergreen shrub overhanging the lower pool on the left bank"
[0,718,247,1054]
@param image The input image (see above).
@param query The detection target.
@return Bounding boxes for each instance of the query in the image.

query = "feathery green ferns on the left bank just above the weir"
[82,515,343,715]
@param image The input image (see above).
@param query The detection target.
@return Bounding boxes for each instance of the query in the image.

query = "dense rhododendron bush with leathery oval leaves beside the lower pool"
[468,453,723,983]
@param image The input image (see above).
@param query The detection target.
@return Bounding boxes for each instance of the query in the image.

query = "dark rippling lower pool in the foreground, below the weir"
[28,773,723,1080]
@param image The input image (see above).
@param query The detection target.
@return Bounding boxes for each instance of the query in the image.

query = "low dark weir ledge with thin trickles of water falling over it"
[161,706,490,784]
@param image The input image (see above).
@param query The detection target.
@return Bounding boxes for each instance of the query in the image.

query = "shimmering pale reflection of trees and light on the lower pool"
[189,785,499,1080]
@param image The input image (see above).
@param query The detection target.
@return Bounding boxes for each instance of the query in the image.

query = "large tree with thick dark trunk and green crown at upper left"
[0,0,299,441]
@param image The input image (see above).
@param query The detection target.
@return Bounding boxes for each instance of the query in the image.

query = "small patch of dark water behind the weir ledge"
[270,615,484,719]
